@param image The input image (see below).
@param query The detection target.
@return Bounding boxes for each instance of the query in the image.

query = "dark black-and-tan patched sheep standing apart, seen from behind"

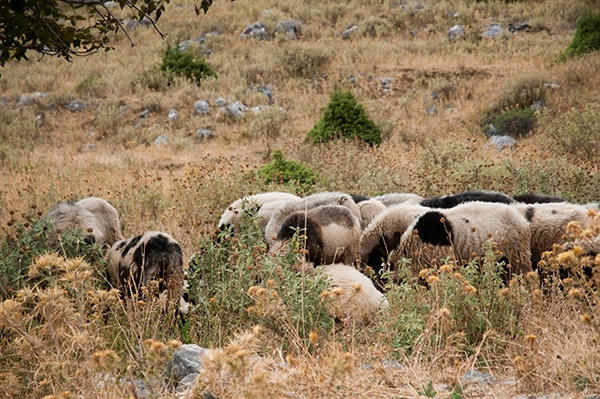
[106,231,184,308]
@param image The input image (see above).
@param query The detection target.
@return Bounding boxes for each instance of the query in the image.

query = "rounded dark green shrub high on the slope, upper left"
[160,45,217,85]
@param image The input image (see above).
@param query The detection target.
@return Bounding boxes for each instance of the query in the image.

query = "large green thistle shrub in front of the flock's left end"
[188,210,334,350]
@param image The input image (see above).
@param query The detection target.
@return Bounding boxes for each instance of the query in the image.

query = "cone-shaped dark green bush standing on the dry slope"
[306,87,381,145]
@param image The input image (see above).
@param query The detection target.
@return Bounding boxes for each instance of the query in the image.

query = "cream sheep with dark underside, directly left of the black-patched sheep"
[359,204,430,275]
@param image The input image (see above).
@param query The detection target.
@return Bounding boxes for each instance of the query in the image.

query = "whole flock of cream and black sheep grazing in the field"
[42,191,600,323]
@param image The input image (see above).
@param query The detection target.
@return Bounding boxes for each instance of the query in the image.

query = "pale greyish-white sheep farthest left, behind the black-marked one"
[40,197,123,247]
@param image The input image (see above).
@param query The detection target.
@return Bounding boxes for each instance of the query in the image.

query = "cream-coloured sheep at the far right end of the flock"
[513,202,596,268]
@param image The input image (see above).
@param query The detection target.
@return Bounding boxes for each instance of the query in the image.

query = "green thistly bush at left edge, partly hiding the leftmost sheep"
[0,215,106,300]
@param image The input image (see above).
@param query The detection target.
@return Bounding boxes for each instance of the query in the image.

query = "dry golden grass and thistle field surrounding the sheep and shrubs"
[0,0,600,399]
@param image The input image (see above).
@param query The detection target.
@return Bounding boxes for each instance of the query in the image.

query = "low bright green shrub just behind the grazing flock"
[258,150,320,191]
